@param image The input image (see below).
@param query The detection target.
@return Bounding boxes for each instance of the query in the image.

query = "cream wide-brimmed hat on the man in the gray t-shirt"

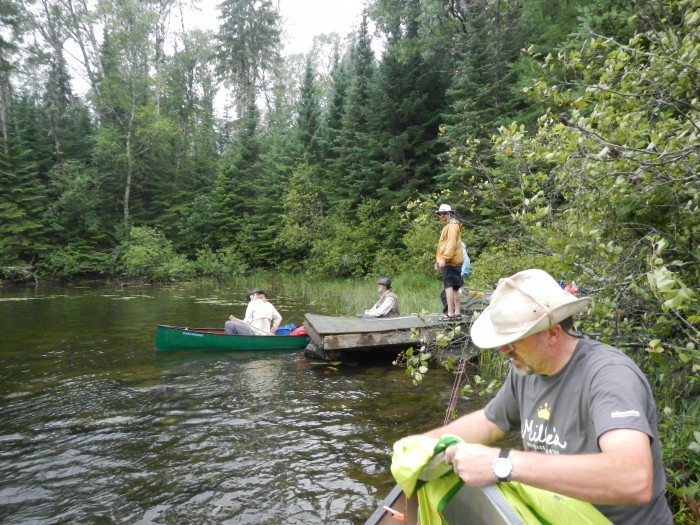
[471,269,592,348]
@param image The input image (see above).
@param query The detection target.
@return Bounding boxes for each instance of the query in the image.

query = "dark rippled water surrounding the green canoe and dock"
[0,285,476,524]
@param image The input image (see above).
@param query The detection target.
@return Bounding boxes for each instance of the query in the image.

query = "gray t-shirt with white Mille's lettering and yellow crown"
[485,338,673,525]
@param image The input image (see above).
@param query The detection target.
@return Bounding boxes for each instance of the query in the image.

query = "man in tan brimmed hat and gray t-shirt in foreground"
[416,269,673,525]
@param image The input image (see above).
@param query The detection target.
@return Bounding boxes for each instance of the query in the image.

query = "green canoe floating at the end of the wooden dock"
[155,324,309,352]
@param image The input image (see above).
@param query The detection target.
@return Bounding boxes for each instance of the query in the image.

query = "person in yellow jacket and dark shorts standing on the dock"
[435,204,464,321]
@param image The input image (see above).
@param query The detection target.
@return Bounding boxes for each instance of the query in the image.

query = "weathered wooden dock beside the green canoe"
[304,289,491,361]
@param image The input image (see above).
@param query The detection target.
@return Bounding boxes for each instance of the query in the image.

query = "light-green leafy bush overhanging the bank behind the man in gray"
[456,1,700,522]
